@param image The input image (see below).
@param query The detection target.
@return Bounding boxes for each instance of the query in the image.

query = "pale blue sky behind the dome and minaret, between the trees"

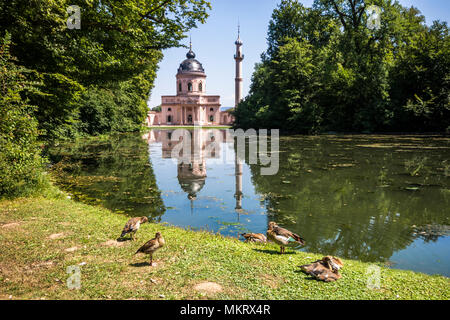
[149,0,450,108]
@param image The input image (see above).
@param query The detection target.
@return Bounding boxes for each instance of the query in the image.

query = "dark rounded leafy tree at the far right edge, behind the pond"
[391,22,450,132]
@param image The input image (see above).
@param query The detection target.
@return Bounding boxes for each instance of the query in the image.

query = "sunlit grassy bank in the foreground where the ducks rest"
[0,198,450,299]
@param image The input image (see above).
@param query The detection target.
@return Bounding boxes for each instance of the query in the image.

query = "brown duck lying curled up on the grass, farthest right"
[299,256,344,282]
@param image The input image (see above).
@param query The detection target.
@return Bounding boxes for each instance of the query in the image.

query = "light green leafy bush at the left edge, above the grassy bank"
[0,33,47,198]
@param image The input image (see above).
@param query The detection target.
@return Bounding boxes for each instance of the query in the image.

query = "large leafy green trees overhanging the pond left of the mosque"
[0,0,210,138]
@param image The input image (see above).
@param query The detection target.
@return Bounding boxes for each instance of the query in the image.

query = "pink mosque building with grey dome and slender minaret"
[146,32,244,127]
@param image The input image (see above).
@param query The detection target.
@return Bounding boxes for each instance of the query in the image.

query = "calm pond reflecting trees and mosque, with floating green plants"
[48,129,450,276]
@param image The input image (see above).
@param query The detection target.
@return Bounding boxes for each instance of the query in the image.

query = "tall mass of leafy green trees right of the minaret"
[234,0,450,133]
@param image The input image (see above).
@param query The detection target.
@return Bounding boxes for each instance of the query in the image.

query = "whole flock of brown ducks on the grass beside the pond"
[120,217,344,282]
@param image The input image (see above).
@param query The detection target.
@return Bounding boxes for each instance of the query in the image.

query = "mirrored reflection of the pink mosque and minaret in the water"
[144,129,243,212]
